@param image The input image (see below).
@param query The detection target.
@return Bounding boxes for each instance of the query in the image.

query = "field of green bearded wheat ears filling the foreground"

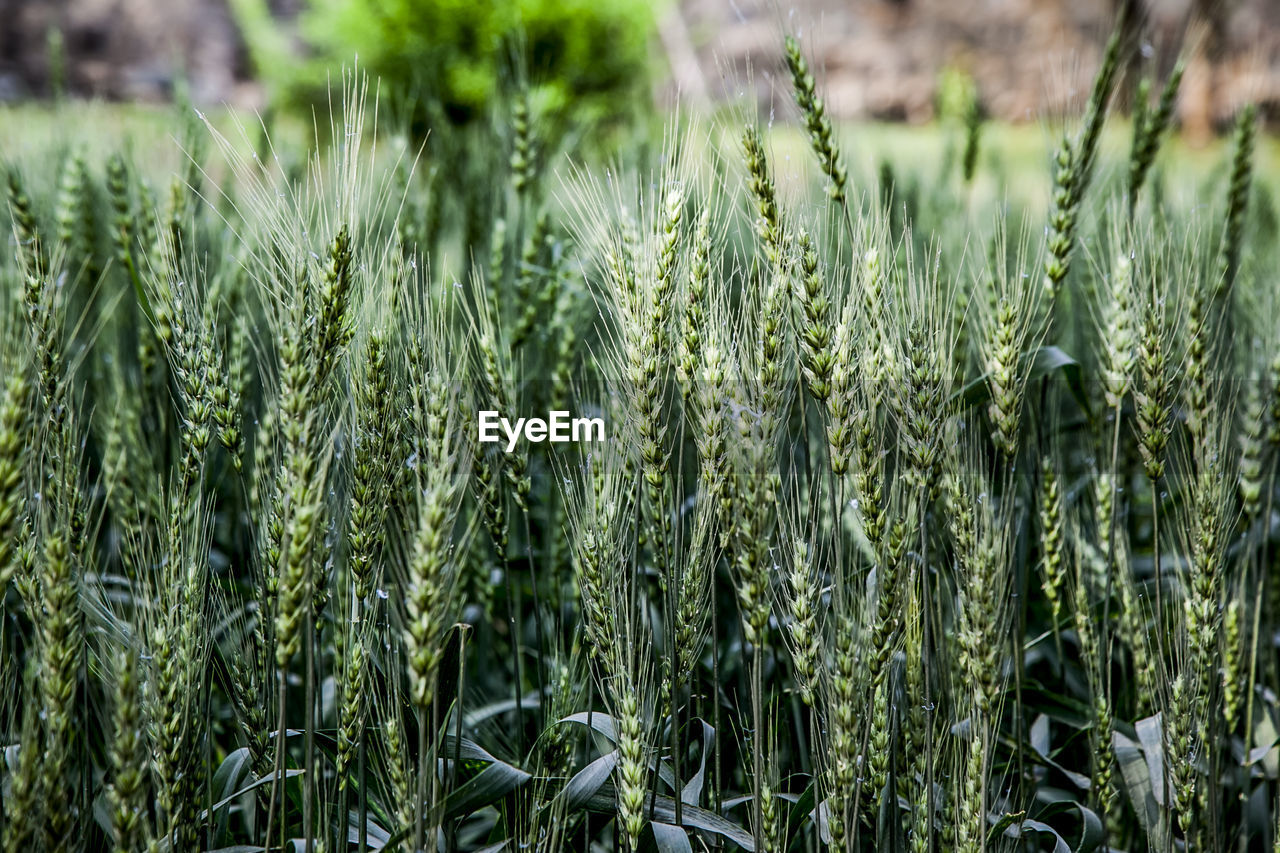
[0,14,1280,853]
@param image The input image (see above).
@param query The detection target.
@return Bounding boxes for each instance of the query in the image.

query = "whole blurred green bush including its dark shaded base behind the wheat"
[229,0,655,263]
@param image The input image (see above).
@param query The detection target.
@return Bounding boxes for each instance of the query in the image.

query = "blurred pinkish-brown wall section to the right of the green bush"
[664,0,1280,133]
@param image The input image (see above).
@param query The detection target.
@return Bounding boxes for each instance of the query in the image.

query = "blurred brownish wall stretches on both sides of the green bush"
[0,0,1280,136]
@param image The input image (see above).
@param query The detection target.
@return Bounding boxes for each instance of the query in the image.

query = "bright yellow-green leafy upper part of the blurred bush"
[230,0,653,134]
